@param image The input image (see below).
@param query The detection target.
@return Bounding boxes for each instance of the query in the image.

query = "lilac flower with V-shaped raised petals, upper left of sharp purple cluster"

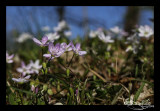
[33,36,48,47]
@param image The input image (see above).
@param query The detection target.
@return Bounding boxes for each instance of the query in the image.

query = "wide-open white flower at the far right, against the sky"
[138,25,153,38]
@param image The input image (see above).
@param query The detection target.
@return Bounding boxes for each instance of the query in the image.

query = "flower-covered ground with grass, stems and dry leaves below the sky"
[6,21,154,105]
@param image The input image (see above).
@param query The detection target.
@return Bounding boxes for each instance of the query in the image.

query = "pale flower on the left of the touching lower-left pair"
[17,62,33,76]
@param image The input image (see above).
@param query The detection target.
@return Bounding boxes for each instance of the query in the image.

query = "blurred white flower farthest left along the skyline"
[16,33,33,43]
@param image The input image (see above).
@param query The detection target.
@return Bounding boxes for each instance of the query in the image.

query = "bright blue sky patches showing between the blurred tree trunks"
[6,6,153,38]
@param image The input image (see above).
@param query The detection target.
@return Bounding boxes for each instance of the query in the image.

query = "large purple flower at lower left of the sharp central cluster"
[43,42,64,59]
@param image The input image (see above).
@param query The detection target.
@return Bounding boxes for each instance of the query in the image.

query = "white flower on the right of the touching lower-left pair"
[29,60,42,74]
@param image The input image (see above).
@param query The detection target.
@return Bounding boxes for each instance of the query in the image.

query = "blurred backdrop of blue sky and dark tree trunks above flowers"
[6,6,154,50]
